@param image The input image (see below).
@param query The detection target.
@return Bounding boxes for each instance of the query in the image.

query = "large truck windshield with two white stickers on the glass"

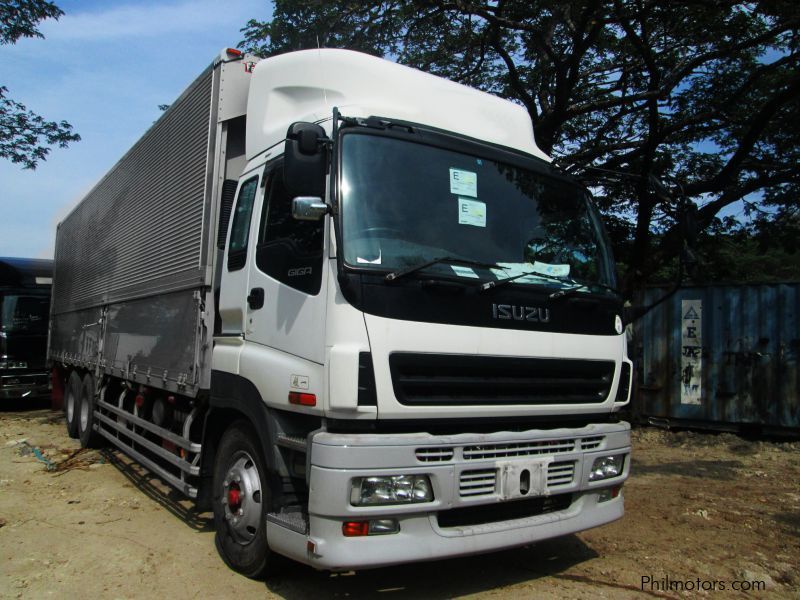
[340,133,616,293]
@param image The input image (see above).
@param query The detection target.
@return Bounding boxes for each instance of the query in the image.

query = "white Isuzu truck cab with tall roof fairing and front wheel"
[210,50,631,572]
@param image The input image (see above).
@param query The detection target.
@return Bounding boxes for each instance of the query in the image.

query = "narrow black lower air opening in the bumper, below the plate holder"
[436,494,572,528]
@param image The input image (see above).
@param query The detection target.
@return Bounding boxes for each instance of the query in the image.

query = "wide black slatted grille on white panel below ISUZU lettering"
[389,352,614,406]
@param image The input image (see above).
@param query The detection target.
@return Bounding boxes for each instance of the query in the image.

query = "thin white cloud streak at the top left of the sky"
[41,0,263,42]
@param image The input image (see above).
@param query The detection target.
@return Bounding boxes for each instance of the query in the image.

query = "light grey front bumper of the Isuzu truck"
[268,423,630,570]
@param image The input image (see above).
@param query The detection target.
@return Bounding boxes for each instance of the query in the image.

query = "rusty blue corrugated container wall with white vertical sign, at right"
[632,283,800,431]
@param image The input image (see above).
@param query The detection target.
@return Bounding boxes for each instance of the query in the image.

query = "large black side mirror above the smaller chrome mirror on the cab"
[283,122,328,198]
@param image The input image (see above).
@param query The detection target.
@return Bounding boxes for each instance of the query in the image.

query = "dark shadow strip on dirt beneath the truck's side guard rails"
[102,448,214,532]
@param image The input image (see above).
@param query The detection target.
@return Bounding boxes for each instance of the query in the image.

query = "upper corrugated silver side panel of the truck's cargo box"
[53,68,216,314]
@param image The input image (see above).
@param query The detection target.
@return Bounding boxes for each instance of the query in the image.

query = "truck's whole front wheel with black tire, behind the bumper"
[211,421,276,579]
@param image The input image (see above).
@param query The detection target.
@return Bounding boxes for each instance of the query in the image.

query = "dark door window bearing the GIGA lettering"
[256,164,325,295]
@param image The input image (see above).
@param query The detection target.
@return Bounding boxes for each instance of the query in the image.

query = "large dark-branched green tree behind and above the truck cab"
[241,0,800,294]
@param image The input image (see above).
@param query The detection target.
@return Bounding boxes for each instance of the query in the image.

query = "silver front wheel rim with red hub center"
[222,451,262,544]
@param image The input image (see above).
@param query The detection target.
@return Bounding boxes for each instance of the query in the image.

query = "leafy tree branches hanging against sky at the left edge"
[0,0,81,169]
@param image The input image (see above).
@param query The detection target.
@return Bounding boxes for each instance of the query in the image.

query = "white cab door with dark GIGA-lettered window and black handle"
[245,159,329,364]
